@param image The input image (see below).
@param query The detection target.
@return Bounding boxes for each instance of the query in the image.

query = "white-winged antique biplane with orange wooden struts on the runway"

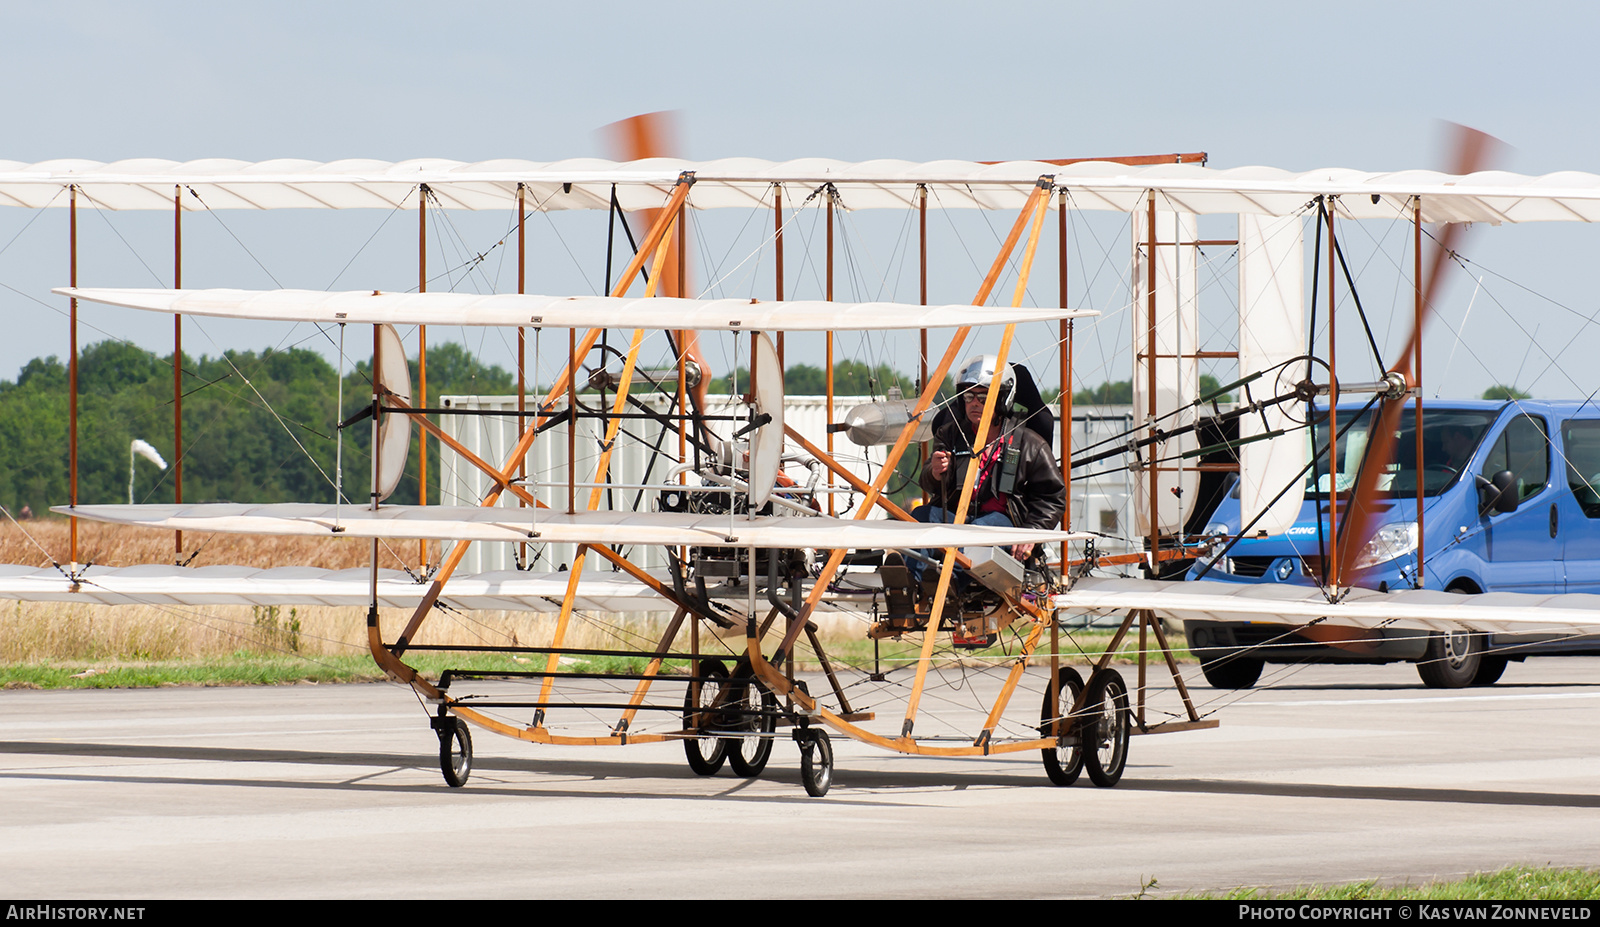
[9,143,1600,796]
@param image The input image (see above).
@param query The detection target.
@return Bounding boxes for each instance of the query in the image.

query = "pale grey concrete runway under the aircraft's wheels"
[0,658,1600,898]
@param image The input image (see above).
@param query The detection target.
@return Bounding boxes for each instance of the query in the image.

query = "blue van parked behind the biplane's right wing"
[1184,400,1600,688]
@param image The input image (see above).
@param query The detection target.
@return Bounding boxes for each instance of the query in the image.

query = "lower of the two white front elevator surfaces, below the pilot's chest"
[53,503,1090,549]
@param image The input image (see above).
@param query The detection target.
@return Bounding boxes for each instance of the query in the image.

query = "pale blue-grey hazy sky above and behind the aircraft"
[0,0,1600,397]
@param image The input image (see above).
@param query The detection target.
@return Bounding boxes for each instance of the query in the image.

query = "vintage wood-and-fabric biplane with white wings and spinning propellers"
[9,139,1600,796]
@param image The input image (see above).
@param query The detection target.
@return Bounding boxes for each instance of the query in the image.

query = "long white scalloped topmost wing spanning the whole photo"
[9,159,1600,224]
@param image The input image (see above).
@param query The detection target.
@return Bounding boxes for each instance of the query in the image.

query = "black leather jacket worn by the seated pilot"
[922,419,1067,528]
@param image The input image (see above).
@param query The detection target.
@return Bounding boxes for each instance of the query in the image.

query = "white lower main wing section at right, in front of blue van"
[1054,576,1600,632]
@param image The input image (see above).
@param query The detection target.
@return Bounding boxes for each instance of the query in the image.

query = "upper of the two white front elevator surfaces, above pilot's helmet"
[54,287,1099,331]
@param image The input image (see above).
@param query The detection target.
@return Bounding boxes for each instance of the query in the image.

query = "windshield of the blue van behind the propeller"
[1306,408,1498,498]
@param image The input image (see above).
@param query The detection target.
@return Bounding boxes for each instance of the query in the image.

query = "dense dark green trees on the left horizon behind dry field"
[0,341,514,512]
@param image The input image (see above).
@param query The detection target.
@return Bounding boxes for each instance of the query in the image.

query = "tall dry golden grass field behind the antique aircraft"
[0,517,1158,685]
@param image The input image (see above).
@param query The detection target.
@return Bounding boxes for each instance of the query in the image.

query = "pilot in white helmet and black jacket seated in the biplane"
[906,354,1067,580]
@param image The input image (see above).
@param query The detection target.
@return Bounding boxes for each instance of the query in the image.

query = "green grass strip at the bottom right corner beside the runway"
[1182,866,1600,901]
